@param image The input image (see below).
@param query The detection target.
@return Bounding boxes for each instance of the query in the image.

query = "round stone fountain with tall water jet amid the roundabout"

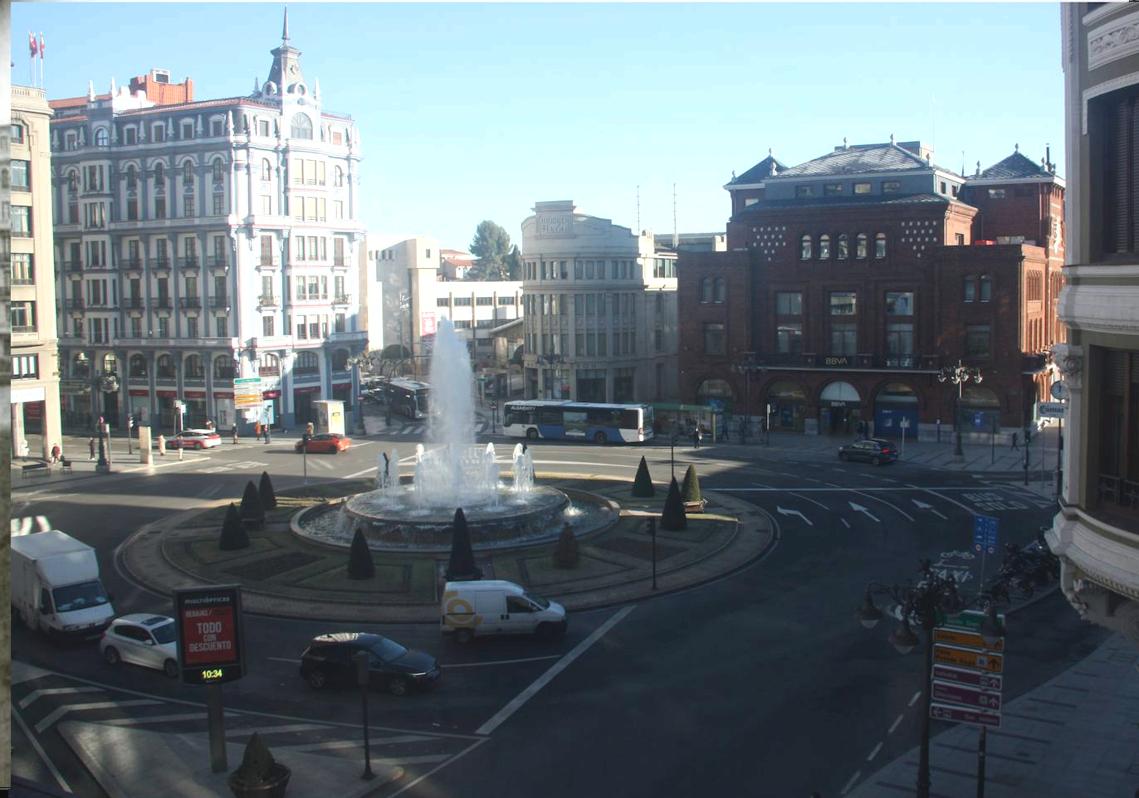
[294,320,611,550]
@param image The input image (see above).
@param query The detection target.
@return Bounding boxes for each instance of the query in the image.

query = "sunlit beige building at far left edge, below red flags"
[9,85,63,458]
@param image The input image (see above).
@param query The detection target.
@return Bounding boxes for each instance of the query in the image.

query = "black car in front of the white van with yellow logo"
[301,632,442,696]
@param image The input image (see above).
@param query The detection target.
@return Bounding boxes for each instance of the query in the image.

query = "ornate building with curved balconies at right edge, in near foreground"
[1047,2,1139,644]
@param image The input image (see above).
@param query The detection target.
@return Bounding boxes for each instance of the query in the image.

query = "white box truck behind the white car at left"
[11,529,115,637]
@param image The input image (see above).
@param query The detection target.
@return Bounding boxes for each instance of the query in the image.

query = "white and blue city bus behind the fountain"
[502,400,653,443]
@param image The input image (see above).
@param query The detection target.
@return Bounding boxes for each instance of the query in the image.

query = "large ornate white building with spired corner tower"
[51,13,367,429]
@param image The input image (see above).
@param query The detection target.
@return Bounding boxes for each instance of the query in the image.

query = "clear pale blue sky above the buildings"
[11,2,1064,249]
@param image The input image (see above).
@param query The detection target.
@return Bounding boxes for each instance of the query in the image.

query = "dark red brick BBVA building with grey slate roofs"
[678,141,1064,441]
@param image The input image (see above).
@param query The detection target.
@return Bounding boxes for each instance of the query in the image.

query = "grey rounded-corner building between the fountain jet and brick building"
[522,200,678,402]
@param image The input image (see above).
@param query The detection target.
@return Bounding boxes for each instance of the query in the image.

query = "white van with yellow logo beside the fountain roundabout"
[441,579,566,643]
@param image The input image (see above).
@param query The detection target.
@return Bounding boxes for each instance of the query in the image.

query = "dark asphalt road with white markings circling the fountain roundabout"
[13,430,1104,798]
